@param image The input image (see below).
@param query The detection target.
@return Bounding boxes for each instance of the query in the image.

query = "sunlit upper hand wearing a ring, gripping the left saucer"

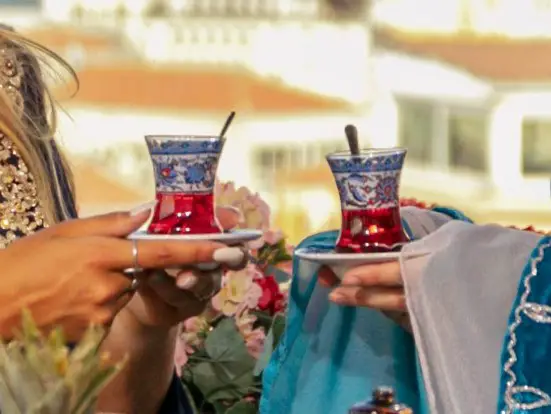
[0,211,225,341]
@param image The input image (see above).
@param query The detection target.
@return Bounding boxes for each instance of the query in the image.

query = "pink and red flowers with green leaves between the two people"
[176,183,291,414]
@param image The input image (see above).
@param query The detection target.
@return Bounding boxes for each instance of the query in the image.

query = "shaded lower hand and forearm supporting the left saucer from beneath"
[99,205,247,413]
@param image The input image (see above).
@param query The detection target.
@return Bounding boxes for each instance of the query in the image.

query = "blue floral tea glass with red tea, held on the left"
[145,135,224,234]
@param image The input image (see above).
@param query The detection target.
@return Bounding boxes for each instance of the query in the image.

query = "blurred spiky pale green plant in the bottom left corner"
[0,311,124,414]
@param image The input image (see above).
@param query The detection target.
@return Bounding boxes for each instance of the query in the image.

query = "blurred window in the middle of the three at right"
[448,112,488,172]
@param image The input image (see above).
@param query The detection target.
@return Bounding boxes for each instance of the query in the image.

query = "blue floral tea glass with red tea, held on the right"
[327,148,407,253]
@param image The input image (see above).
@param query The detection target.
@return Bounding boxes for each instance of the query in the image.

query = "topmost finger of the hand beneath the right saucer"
[342,261,403,287]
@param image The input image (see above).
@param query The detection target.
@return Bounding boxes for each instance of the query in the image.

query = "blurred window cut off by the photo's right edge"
[522,120,551,174]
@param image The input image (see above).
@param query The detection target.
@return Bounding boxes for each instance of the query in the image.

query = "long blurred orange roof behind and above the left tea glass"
[74,64,349,112]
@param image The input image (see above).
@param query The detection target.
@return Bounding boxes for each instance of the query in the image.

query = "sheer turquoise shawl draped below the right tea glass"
[260,209,468,414]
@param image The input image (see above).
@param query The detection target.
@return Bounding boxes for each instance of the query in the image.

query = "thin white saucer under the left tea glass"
[132,229,262,245]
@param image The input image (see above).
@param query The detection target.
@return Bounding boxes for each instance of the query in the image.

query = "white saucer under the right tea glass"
[294,247,429,279]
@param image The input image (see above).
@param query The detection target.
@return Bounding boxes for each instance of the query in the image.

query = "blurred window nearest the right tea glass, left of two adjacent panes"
[398,101,435,164]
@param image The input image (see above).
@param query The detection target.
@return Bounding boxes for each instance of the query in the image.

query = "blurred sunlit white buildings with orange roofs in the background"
[4,0,551,242]
